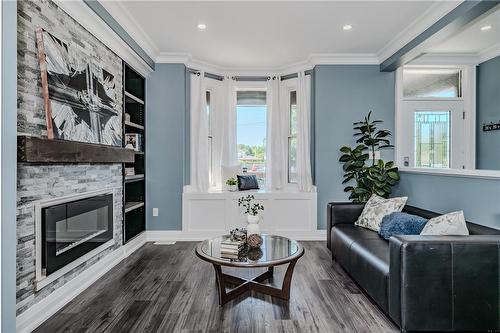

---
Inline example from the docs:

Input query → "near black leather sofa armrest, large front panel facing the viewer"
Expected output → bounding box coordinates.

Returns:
[389,235,500,331]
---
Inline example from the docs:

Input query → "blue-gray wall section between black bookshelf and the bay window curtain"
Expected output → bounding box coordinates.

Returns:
[146,64,189,230]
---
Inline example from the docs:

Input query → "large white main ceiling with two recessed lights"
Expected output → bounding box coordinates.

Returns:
[101,1,458,68]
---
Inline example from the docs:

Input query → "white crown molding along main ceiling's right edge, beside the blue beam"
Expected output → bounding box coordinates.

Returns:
[377,1,462,63]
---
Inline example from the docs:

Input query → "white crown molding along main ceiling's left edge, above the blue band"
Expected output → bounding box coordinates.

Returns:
[100,1,160,59]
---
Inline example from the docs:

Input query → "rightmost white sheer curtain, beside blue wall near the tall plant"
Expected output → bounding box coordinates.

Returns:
[297,72,313,192]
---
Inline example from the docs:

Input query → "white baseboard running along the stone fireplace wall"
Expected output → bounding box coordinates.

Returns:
[16,233,146,333]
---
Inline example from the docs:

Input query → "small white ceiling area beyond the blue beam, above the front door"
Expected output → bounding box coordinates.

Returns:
[427,9,500,54]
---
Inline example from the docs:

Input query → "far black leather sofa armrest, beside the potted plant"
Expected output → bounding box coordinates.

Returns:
[326,202,365,250]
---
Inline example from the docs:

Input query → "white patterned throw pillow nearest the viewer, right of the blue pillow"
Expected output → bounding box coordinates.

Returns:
[420,211,469,236]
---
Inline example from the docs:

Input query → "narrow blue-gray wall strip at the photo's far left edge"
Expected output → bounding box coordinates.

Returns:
[0,1,17,333]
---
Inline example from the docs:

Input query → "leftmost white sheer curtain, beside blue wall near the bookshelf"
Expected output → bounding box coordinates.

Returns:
[190,72,209,192]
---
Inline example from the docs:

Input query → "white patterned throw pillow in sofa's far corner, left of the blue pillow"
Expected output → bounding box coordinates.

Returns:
[354,194,408,232]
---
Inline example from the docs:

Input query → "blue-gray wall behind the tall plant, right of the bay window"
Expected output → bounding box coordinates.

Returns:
[313,65,395,229]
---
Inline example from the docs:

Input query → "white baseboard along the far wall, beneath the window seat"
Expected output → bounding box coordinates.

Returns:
[146,230,326,242]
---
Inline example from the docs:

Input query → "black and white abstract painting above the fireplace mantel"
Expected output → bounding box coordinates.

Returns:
[36,29,122,146]
